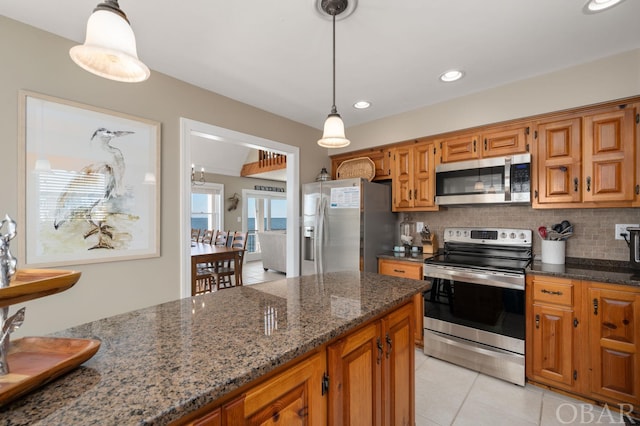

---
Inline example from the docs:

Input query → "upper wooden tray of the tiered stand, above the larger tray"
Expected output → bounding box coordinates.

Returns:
[0,269,80,307]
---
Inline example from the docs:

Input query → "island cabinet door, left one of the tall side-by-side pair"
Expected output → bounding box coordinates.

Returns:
[327,321,384,426]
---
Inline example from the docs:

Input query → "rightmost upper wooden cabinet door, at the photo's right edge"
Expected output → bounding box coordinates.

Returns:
[582,108,635,201]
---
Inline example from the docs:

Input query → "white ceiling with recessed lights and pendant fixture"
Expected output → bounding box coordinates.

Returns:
[0,0,640,133]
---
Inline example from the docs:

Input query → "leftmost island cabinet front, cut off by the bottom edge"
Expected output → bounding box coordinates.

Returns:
[244,351,327,426]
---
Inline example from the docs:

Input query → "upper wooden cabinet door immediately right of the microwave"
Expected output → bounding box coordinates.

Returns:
[536,117,582,203]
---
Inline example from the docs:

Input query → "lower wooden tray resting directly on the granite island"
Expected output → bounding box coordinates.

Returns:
[0,337,100,406]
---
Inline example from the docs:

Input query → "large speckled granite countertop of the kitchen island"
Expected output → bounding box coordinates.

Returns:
[0,272,430,426]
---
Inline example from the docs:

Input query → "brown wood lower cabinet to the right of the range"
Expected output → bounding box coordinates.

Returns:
[525,275,640,412]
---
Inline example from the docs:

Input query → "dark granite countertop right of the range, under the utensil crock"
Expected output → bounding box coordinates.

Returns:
[527,257,640,287]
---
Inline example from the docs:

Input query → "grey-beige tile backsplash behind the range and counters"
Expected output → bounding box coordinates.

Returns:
[404,206,640,261]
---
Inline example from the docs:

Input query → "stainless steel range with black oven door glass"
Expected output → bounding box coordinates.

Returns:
[424,228,532,386]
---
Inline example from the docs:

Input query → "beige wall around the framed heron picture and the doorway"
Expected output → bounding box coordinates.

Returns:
[0,16,329,335]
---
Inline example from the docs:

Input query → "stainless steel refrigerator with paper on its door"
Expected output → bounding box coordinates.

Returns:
[301,178,396,275]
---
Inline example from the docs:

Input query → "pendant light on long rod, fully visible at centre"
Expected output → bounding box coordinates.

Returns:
[318,0,351,148]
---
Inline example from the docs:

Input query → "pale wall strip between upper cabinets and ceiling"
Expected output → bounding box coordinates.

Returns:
[332,49,640,154]
